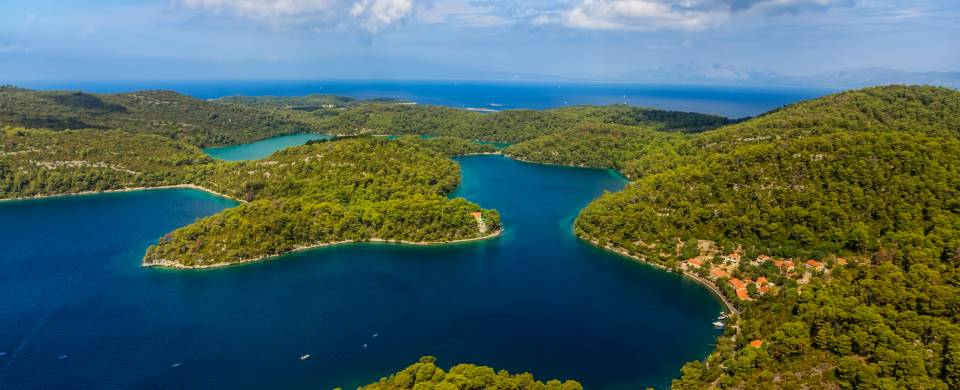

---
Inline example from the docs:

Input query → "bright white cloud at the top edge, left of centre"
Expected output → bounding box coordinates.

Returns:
[173,0,414,33]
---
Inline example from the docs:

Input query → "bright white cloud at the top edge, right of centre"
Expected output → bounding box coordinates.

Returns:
[556,0,853,30]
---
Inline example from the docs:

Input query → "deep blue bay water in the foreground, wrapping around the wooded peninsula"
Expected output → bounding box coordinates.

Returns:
[0,156,721,389]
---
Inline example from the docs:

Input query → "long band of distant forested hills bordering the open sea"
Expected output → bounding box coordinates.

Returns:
[0,86,733,148]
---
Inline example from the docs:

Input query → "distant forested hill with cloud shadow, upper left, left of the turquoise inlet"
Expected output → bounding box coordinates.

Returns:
[0,87,320,147]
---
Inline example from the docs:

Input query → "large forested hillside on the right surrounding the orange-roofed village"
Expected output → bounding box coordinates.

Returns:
[576,86,960,389]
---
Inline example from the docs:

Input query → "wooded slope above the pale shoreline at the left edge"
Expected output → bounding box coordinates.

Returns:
[0,128,213,199]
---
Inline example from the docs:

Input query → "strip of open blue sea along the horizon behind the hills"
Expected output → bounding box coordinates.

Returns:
[22,80,834,118]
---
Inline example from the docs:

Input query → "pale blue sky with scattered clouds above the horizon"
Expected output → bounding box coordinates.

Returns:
[0,0,960,83]
